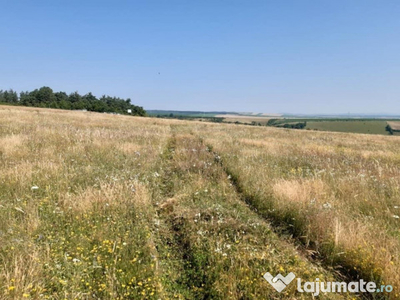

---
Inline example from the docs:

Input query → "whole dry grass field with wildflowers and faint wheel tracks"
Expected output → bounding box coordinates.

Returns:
[0,106,400,299]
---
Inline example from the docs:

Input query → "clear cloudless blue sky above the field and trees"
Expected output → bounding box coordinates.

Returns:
[0,0,400,114]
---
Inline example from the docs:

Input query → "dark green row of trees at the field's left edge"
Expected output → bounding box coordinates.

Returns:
[0,87,146,116]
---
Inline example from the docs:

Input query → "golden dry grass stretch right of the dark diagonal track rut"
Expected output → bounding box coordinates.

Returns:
[199,123,400,297]
